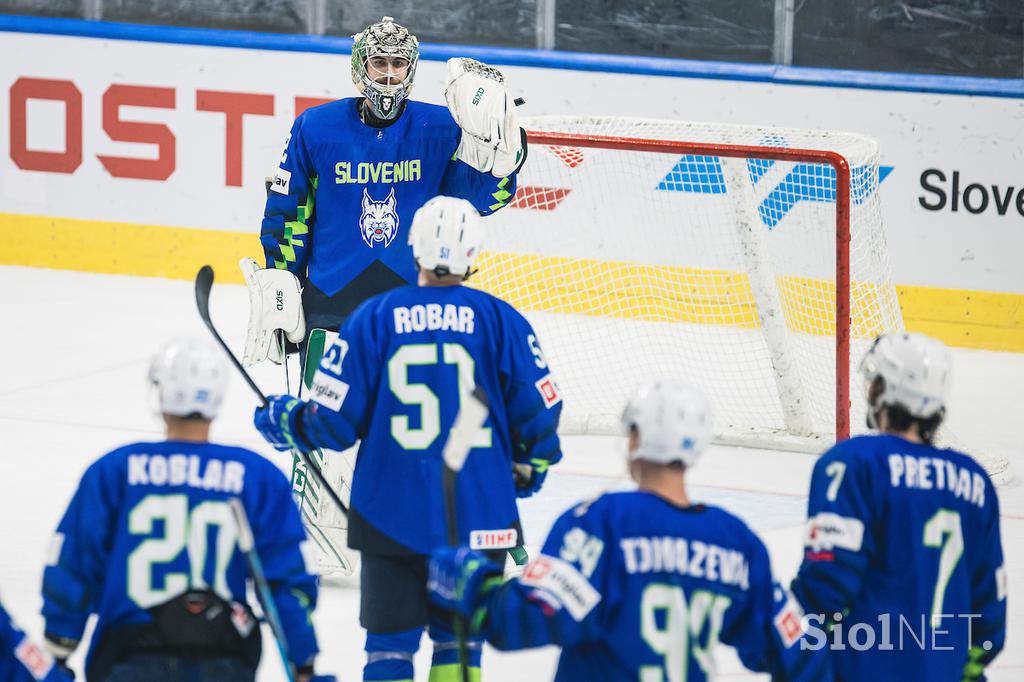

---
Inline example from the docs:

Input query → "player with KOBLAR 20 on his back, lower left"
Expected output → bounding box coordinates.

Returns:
[43,341,317,681]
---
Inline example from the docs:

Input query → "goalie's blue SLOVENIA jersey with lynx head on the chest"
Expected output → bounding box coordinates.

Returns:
[260,97,516,296]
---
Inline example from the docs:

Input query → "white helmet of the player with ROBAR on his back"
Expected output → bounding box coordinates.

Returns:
[409,197,483,279]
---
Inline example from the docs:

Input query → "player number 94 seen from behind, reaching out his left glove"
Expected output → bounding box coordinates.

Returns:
[429,381,830,682]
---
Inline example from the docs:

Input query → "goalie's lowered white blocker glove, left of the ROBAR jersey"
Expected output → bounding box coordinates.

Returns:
[239,258,306,367]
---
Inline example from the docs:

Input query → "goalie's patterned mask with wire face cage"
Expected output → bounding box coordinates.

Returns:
[352,16,420,121]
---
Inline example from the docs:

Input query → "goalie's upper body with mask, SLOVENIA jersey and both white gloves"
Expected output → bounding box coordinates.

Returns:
[243,16,526,366]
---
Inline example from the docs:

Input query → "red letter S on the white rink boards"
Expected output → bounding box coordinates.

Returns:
[96,85,175,180]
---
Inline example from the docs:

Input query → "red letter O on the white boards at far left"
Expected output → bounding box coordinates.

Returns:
[10,78,82,173]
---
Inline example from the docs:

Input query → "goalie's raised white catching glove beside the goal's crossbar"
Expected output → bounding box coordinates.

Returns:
[444,57,526,177]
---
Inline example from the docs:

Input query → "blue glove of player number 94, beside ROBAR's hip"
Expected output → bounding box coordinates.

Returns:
[427,547,503,632]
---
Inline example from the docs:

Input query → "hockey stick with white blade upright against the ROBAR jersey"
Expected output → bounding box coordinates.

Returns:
[442,386,489,682]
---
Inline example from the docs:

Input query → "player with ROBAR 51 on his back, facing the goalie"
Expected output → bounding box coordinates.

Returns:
[255,197,561,680]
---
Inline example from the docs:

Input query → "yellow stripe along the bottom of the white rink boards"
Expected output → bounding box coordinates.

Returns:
[0,213,1024,352]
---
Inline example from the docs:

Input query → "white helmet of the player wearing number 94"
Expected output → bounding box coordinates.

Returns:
[623,379,712,467]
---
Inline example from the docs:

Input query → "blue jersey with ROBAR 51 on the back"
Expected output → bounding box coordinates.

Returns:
[300,286,561,554]
